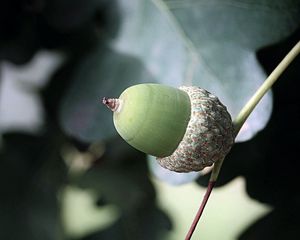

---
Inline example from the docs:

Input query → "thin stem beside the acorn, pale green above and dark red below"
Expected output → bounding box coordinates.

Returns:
[185,41,300,240]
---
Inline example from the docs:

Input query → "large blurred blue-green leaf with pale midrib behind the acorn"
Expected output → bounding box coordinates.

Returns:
[61,0,300,141]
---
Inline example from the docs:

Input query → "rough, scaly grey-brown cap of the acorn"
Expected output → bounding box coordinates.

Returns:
[157,86,234,172]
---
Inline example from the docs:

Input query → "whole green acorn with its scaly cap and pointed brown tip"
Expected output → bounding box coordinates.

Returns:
[102,83,234,172]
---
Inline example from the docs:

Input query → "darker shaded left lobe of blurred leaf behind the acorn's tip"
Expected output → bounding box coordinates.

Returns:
[60,43,154,142]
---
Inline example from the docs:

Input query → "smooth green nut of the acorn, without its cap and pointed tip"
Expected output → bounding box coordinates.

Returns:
[105,84,191,157]
